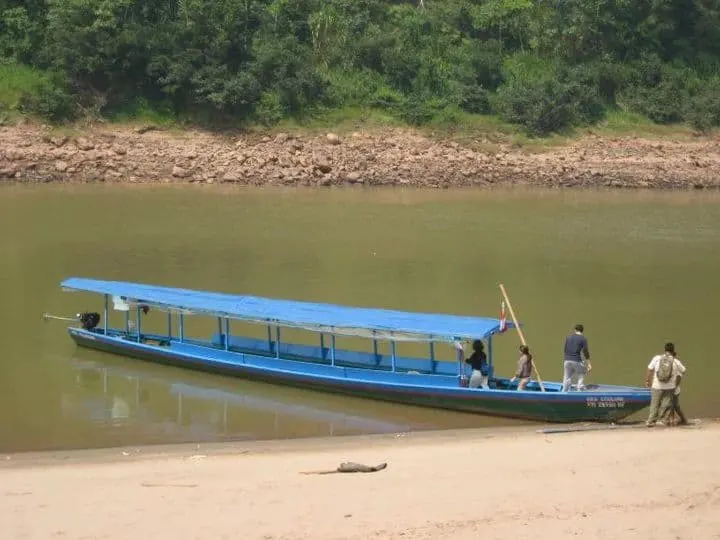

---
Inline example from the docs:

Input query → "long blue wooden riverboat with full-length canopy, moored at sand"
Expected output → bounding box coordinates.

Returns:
[61,278,650,422]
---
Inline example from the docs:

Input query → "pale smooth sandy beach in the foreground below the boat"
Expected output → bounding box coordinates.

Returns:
[0,422,720,540]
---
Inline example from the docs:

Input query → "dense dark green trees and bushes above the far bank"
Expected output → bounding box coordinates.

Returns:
[0,0,720,133]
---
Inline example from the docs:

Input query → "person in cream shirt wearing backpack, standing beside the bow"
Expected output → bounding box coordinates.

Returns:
[645,343,685,427]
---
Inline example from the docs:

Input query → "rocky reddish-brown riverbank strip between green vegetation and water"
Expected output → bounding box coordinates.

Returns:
[0,124,720,189]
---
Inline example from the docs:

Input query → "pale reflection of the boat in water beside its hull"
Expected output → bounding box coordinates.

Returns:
[68,358,417,442]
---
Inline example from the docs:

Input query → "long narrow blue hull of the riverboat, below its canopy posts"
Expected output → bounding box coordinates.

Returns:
[69,328,650,423]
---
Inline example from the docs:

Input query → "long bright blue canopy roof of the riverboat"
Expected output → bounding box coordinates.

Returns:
[61,277,514,342]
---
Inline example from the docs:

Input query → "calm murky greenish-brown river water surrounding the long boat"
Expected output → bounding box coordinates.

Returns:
[0,185,720,452]
